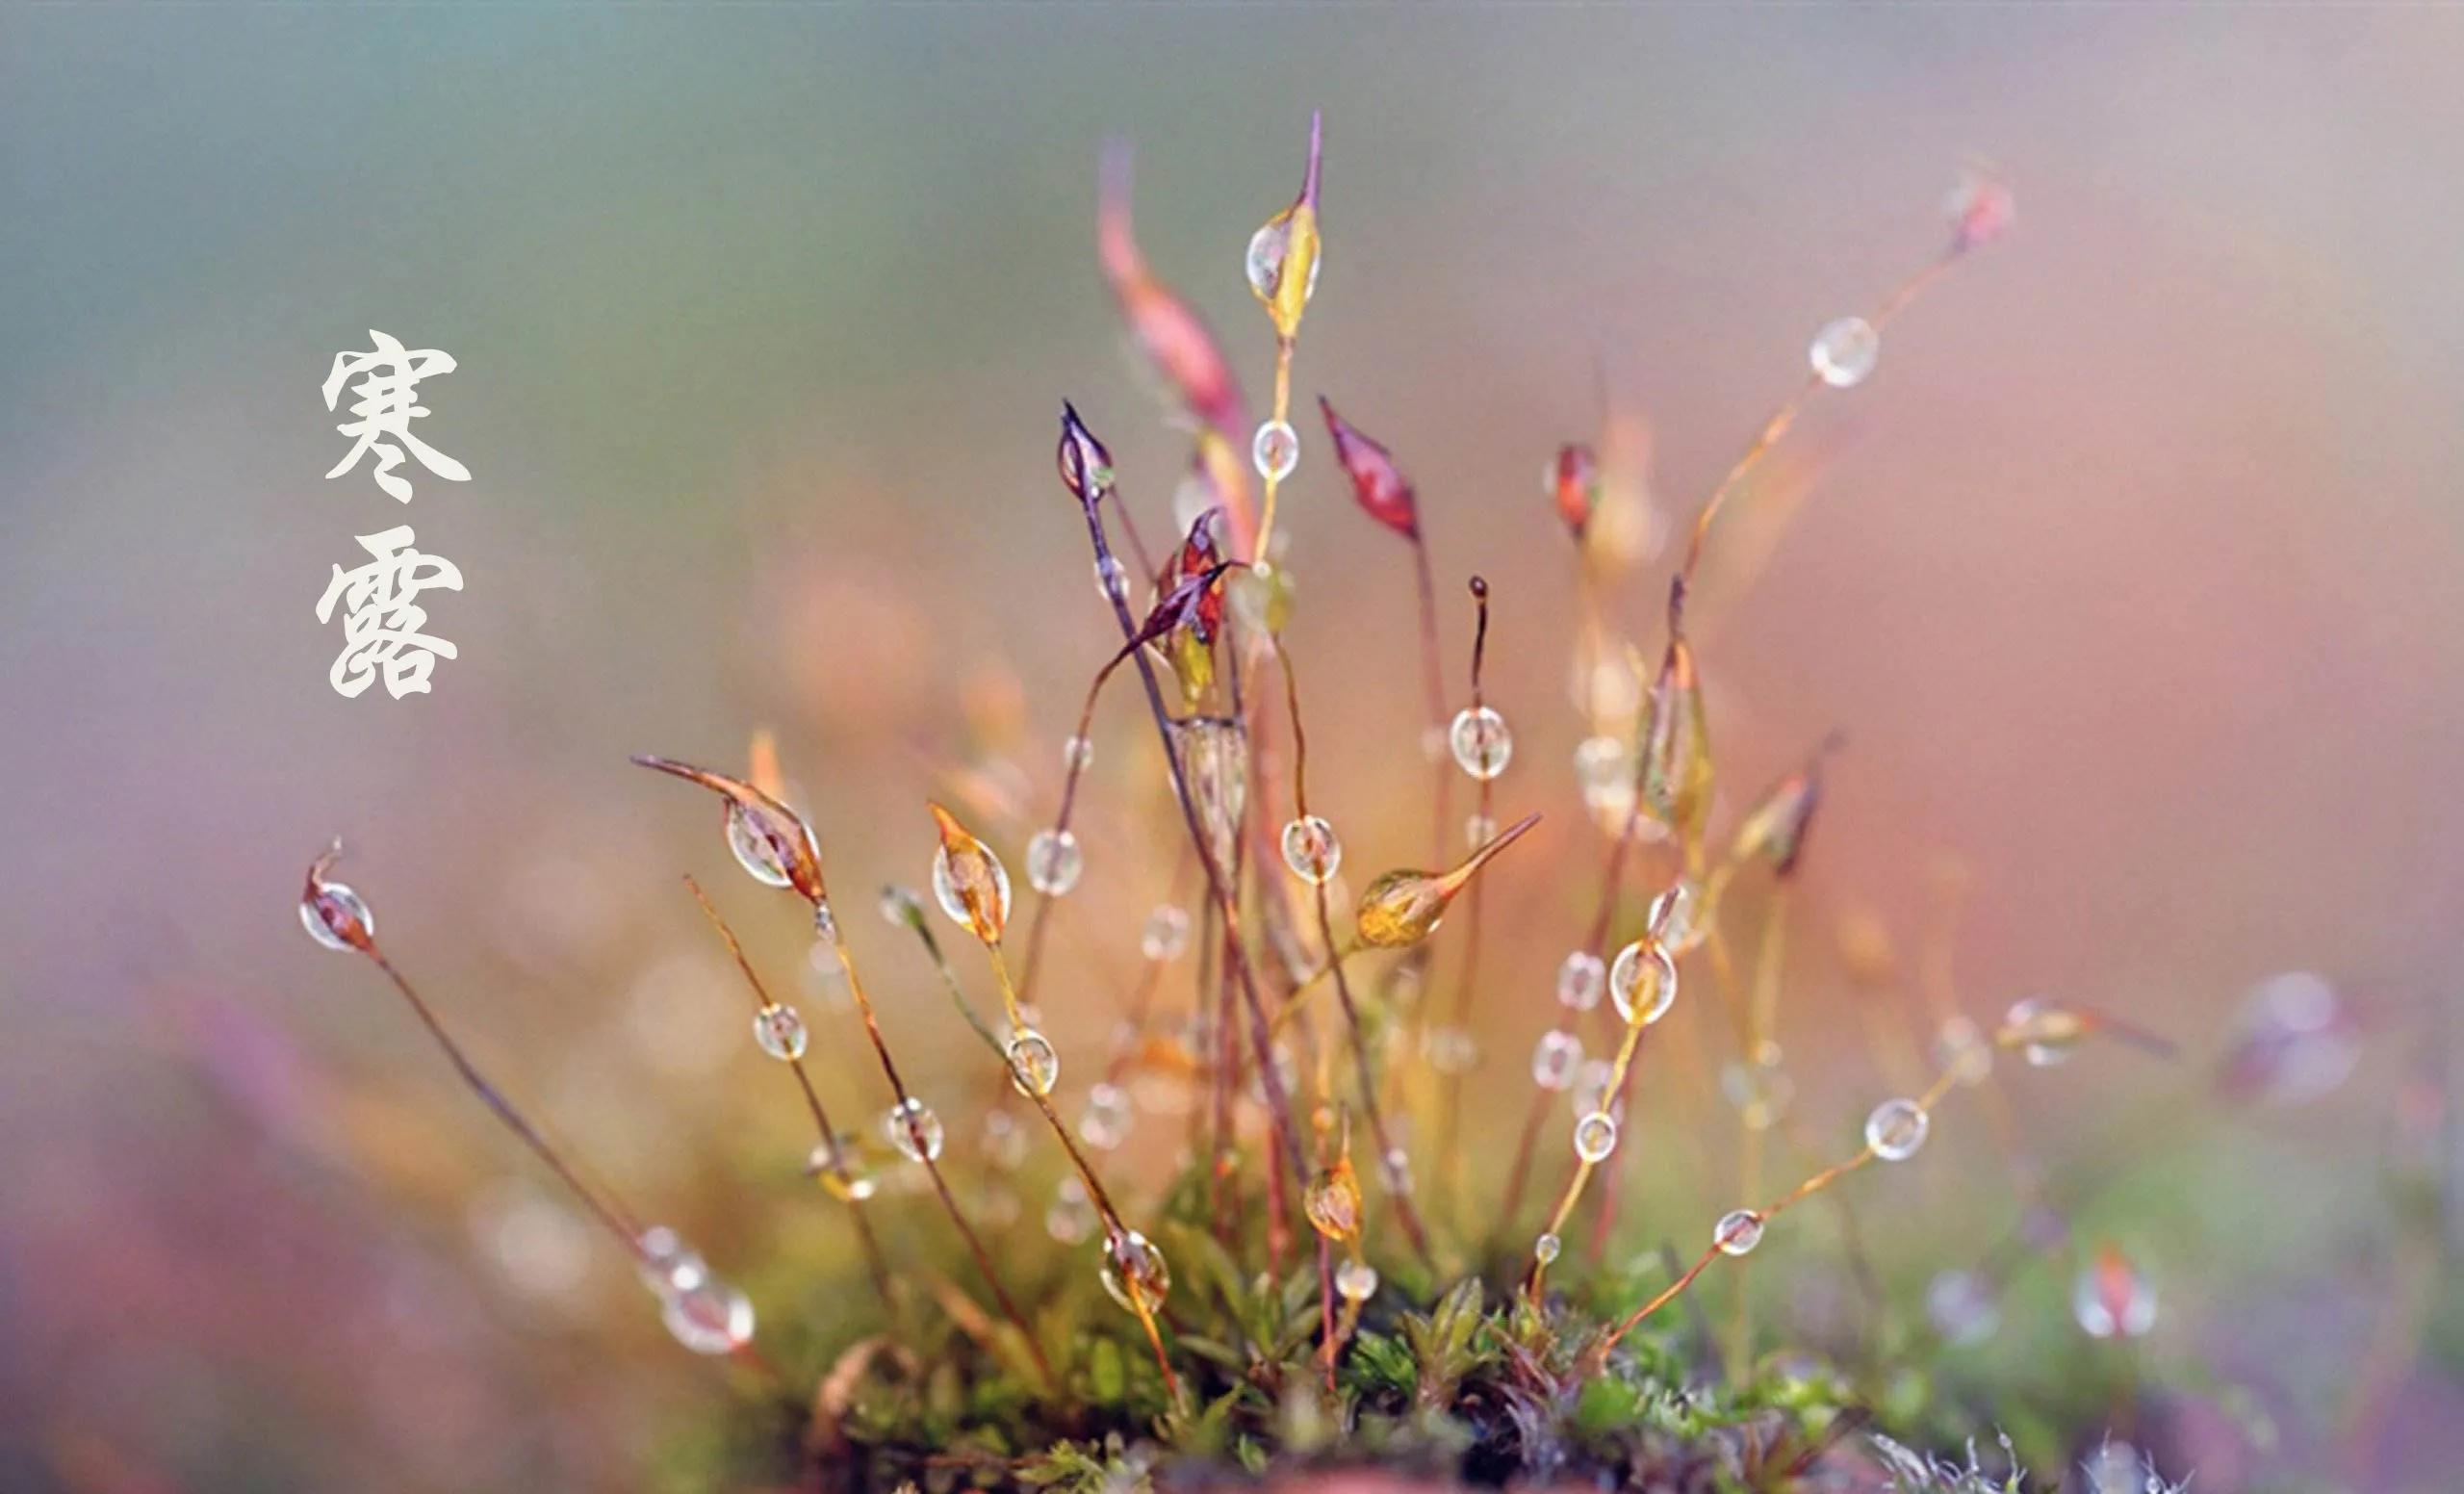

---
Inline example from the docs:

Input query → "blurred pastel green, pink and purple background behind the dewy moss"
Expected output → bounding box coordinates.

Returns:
[0,5,2464,1491]
